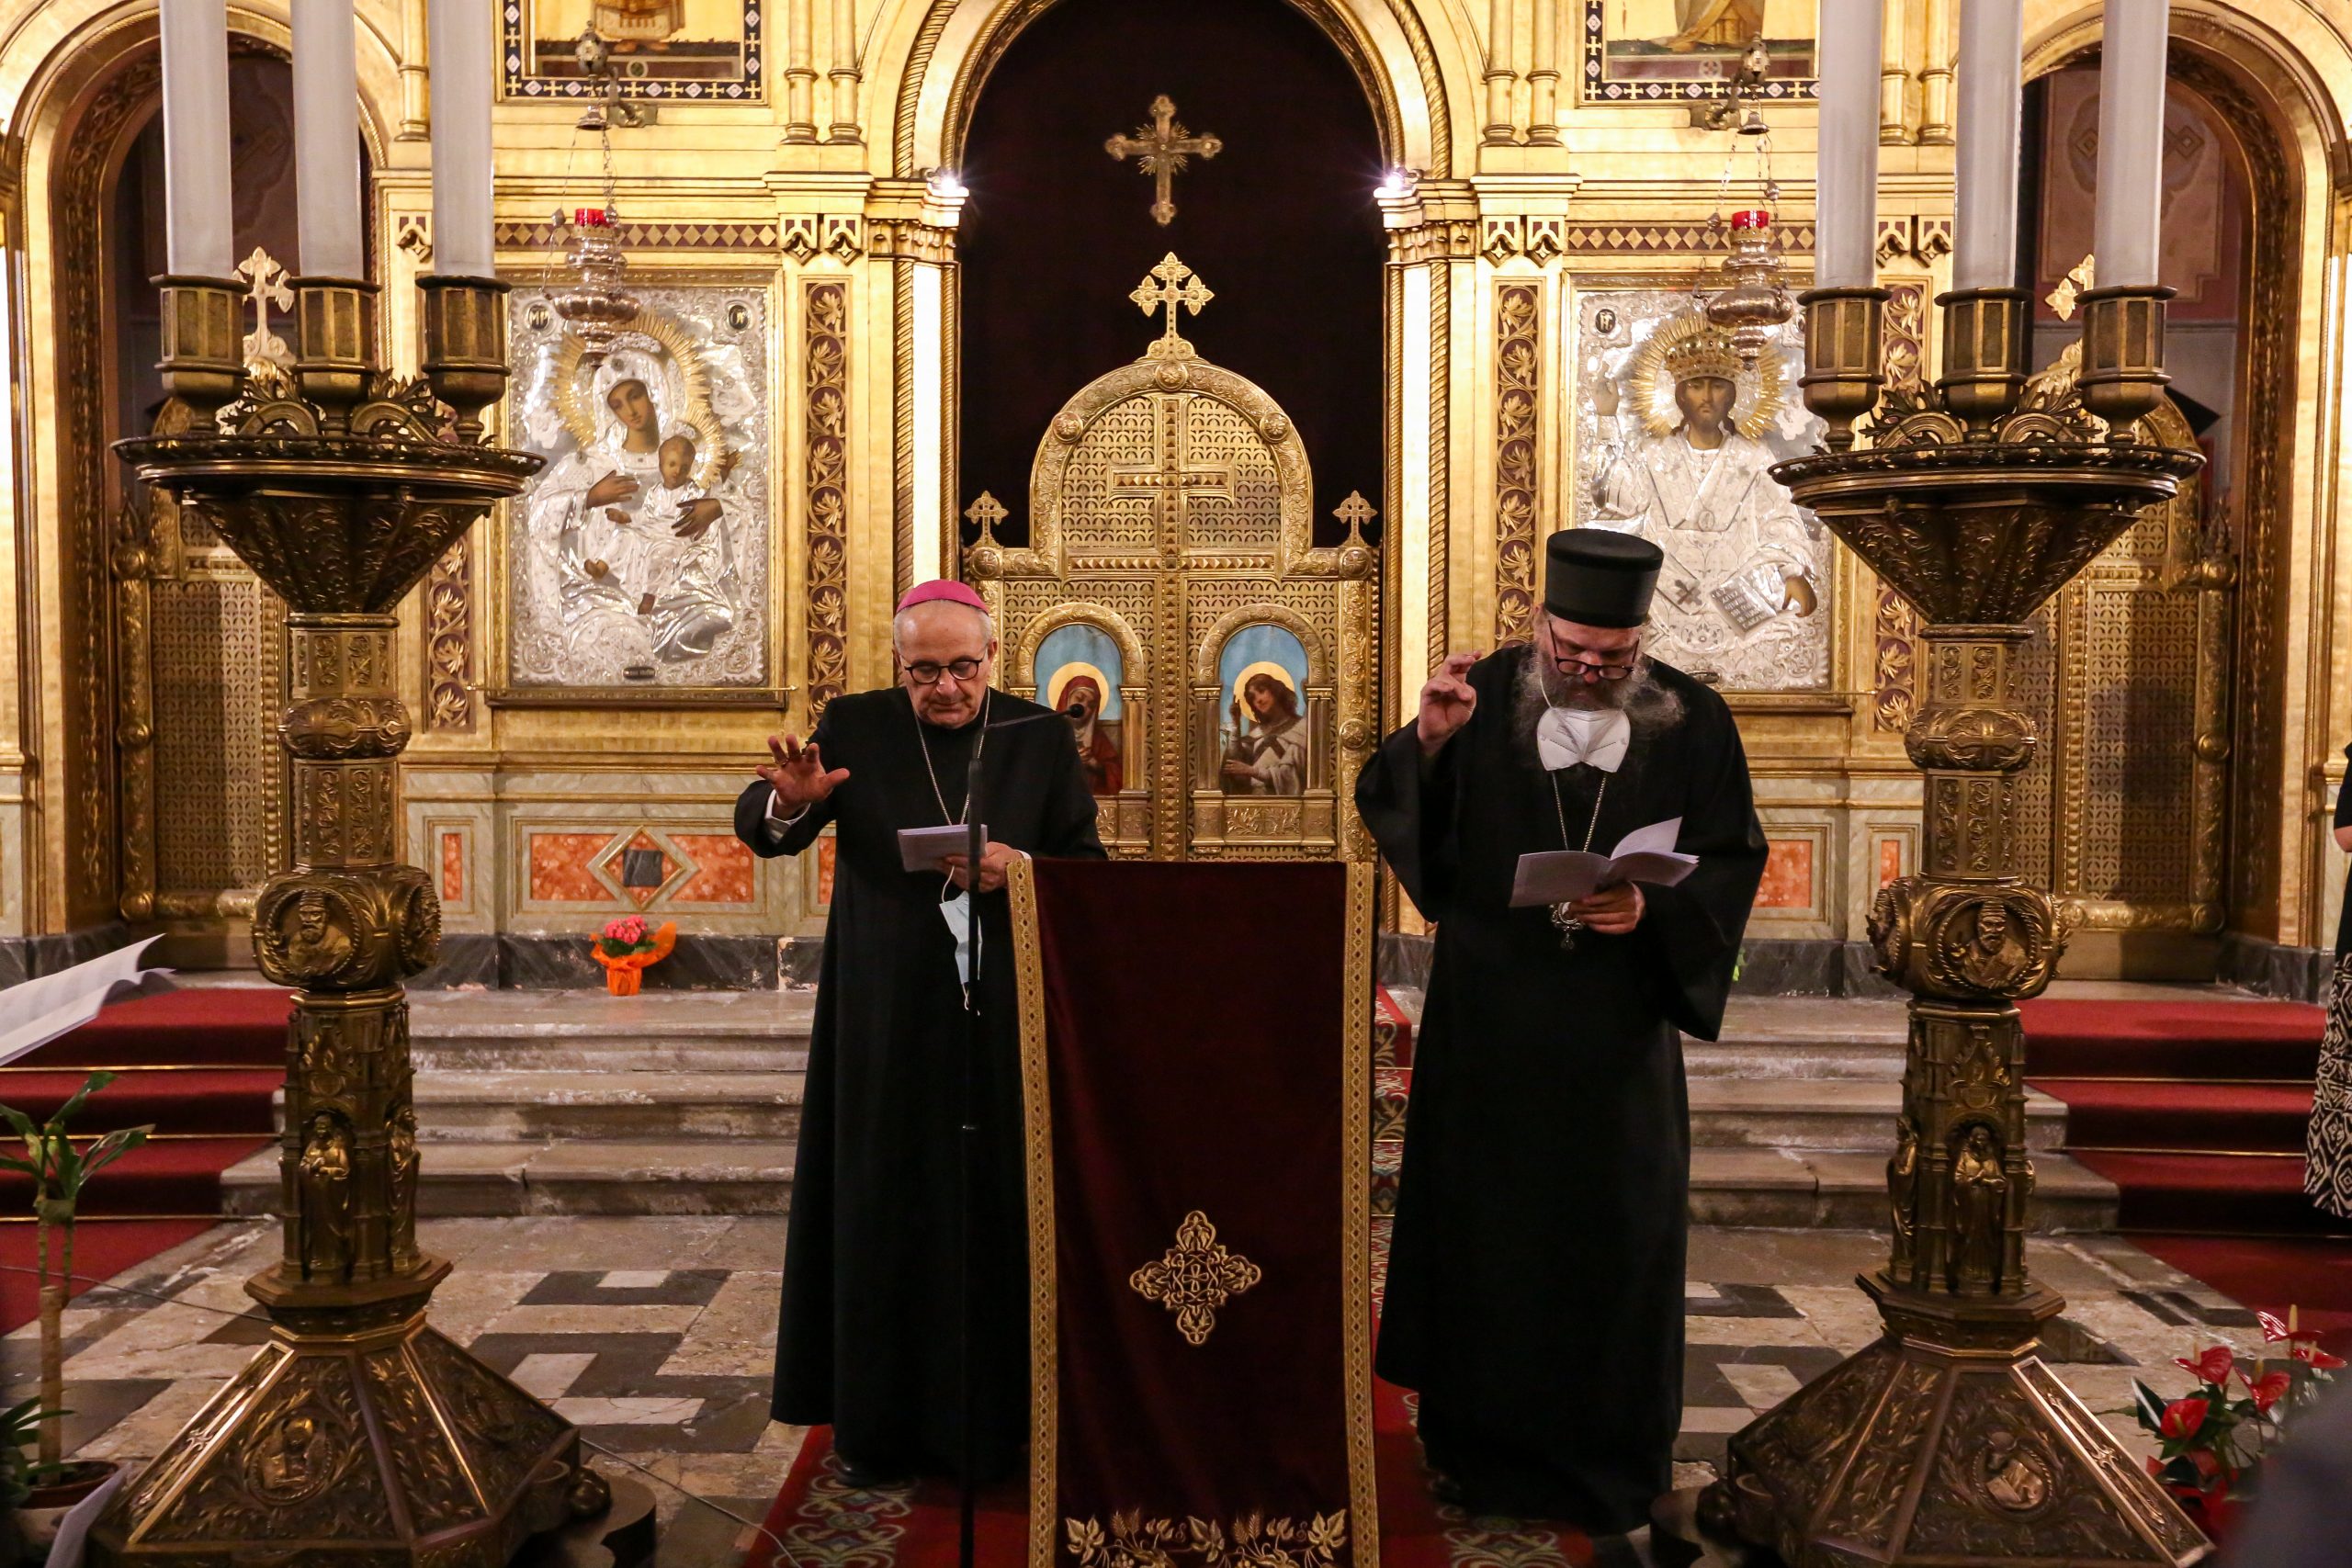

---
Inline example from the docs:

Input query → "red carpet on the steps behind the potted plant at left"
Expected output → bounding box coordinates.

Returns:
[0,985,287,1333]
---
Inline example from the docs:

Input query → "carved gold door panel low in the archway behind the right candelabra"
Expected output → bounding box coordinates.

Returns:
[2018,404,2234,976]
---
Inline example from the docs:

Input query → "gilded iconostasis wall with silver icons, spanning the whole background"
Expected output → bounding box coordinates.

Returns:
[0,0,2352,989]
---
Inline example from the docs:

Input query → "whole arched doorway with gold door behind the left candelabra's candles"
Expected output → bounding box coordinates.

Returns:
[28,18,374,966]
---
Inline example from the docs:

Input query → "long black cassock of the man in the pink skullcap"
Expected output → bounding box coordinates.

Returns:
[736,689,1103,1476]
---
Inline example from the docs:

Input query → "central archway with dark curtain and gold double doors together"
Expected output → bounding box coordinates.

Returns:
[953,0,1393,856]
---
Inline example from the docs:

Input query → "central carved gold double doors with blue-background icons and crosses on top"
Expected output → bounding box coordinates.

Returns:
[967,256,1376,858]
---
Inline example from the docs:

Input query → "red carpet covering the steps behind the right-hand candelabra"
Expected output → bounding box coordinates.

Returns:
[2018,999,2352,1241]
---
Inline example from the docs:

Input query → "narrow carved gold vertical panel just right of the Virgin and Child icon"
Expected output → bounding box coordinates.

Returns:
[799,277,849,724]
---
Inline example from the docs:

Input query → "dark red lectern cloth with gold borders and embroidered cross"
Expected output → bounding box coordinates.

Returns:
[1012,861,1381,1568]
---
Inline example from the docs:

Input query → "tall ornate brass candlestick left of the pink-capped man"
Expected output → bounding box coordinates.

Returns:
[89,277,606,1568]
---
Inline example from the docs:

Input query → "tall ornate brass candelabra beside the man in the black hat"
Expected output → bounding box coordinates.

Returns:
[1701,289,2206,1568]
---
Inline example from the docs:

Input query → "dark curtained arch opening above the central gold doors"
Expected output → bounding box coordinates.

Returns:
[957,0,1387,543]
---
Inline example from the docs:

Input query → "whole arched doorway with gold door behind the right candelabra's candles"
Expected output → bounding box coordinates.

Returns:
[2018,40,2290,980]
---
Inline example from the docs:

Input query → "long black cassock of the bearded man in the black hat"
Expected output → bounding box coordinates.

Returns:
[1355,647,1764,1533]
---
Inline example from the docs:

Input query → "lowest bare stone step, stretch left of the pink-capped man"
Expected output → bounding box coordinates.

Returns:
[221,1138,795,1215]
